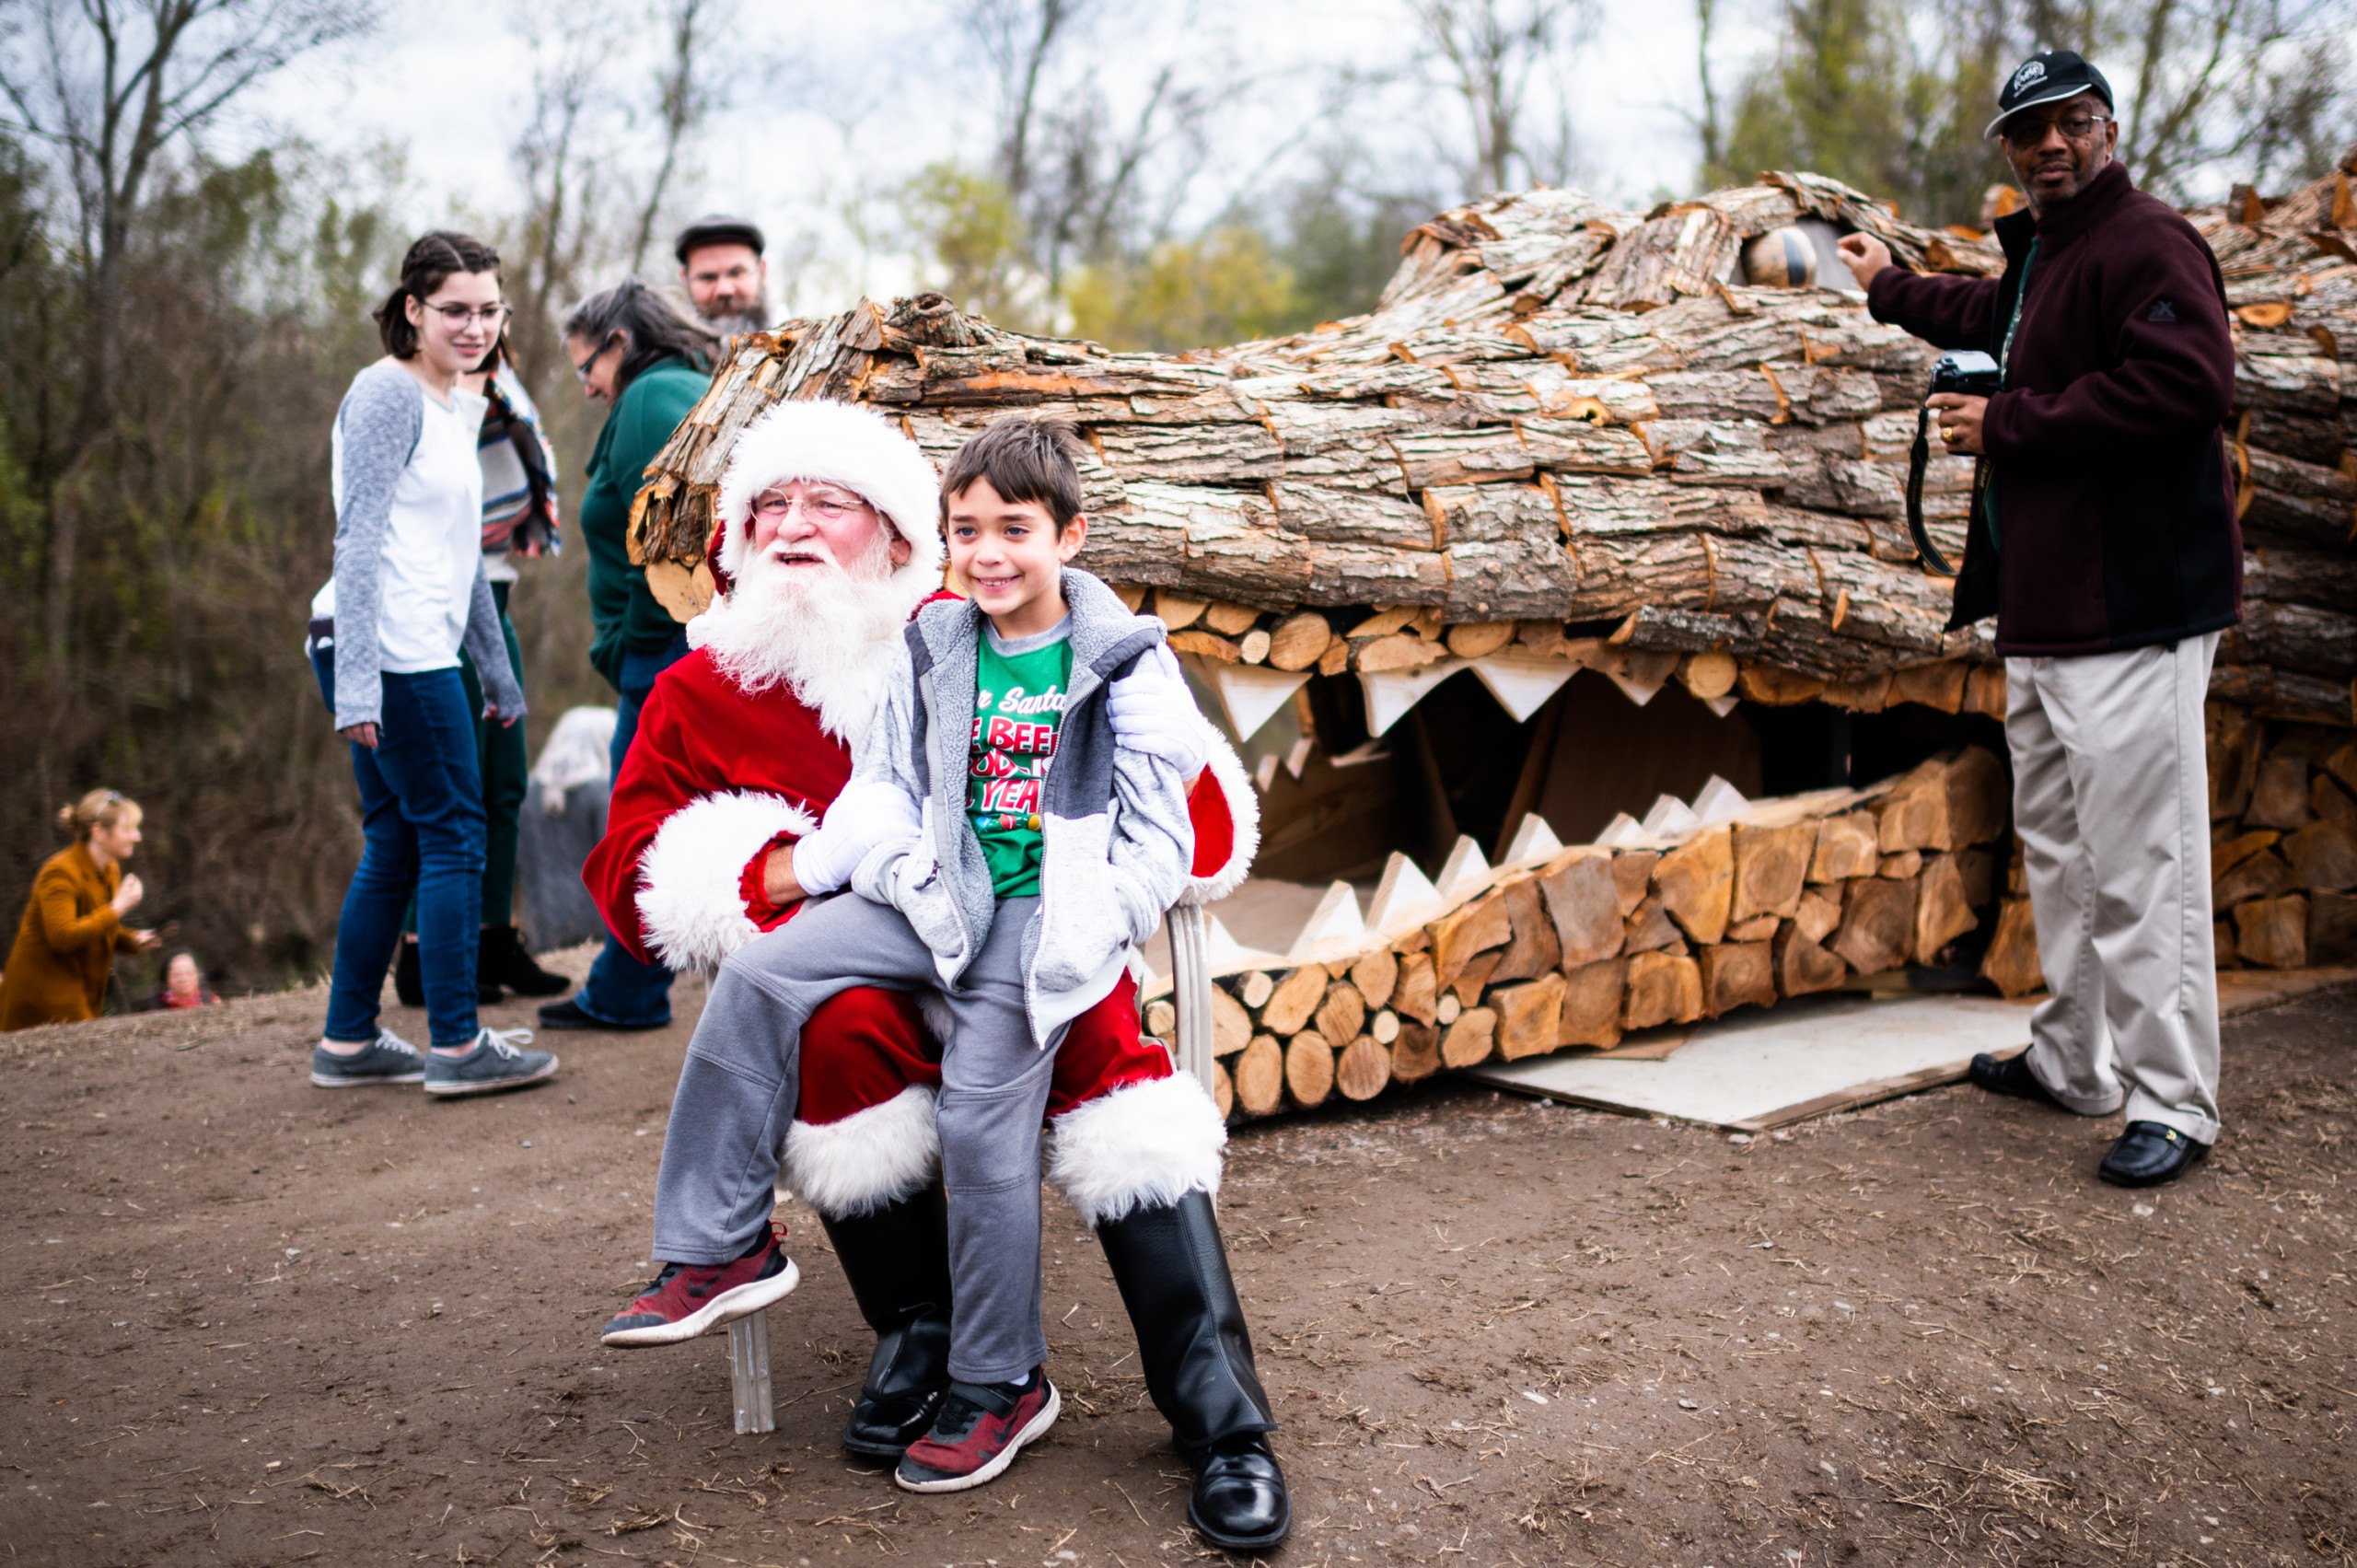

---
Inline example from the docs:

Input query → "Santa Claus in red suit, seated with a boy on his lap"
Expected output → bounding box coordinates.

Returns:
[585,401,1289,1550]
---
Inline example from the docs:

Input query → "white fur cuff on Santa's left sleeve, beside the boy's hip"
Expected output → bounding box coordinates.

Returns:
[639,790,818,974]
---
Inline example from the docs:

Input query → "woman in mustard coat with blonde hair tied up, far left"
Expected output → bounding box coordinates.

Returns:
[0,790,158,1033]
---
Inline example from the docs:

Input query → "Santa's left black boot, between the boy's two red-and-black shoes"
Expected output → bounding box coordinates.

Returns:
[820,1186,950,1459]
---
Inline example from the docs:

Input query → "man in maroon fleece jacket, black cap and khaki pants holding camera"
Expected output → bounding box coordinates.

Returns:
[1840,50,2242,1186]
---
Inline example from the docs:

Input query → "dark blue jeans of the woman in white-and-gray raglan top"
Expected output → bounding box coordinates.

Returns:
[311,648,483,1050]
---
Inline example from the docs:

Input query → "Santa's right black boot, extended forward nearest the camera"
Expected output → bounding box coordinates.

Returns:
[1096,1193,1294,1551]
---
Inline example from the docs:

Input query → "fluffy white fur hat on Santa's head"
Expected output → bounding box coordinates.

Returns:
[704,401,940,604]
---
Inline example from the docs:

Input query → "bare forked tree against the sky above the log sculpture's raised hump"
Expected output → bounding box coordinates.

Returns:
[1411,0,1596,191]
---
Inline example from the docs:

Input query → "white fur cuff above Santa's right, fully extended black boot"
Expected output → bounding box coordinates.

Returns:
[1047,1073,1228,1226]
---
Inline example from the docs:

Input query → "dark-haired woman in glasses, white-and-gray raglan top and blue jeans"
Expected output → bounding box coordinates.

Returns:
[308,231,556,1097]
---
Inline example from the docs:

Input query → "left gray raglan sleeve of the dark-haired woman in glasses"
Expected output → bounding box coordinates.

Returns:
[335,368,422,728]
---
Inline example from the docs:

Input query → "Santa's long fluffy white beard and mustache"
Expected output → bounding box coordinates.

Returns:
[689,538,924,745]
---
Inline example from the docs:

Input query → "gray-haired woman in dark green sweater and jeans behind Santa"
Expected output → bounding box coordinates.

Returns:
[540,278,716,1030]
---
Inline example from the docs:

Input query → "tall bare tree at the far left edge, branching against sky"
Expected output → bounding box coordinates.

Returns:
[0,0,375,665]
